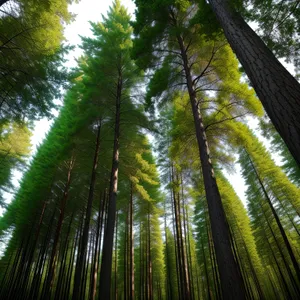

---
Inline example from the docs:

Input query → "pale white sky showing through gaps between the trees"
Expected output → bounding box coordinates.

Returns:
[0,0,286,214]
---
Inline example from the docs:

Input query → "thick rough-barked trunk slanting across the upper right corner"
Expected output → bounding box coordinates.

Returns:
[209,0,300,165]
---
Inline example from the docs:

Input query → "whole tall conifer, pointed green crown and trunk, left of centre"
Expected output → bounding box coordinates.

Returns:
[77,1,139,299]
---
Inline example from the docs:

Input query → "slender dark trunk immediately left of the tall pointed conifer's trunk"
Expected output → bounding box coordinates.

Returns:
[72,121,101,300]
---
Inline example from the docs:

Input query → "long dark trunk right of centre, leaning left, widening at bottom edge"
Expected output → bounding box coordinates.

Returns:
[177,31,246,300]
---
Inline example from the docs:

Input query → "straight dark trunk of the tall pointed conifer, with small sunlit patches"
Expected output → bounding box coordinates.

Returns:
[99,71,123,300]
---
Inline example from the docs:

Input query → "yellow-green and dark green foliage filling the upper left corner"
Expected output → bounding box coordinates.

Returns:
[0,1,75,122]
